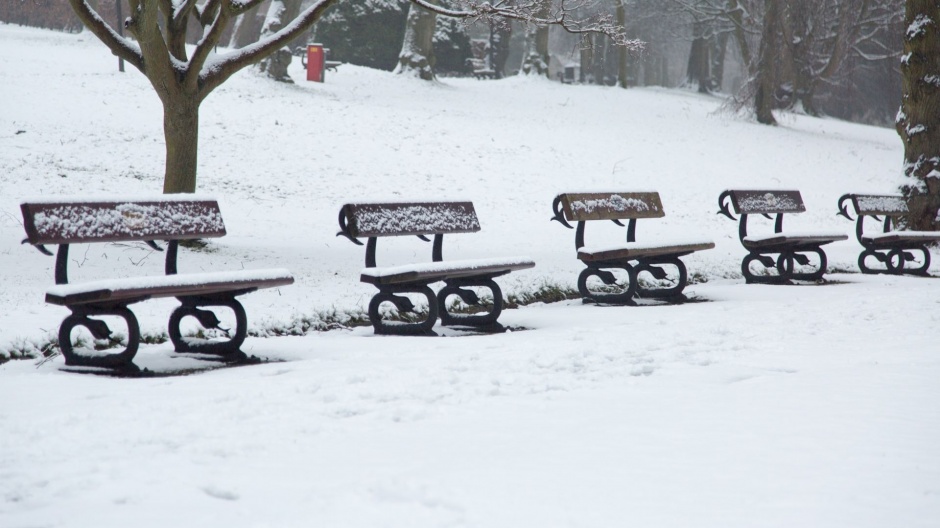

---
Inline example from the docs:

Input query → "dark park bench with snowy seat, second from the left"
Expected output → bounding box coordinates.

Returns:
[337,202,535,335]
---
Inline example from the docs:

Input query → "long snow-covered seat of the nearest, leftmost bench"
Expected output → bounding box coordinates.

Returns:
[46,268,294,306]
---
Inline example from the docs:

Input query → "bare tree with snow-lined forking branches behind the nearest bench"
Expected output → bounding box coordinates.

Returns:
[69,0,631,193]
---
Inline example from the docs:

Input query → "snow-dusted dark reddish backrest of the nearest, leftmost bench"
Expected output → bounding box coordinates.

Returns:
[20,195,225,244]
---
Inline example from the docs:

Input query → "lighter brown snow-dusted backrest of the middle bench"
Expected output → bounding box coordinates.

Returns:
[558,192,666,222]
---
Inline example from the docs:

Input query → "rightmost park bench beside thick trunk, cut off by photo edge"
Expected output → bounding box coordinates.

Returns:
[838,194,940,275]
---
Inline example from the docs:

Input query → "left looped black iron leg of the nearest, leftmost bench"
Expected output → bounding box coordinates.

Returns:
[59,305,140,370]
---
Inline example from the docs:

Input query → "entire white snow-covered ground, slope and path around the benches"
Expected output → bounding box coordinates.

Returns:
[0,25,940,528]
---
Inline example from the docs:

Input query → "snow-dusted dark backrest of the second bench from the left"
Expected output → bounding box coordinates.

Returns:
[340,202,480,237]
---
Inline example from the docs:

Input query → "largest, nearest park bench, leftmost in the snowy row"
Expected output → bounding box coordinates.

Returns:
[20,195,294,371]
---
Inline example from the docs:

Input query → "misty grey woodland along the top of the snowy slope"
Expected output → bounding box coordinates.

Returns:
[0,0,905,126]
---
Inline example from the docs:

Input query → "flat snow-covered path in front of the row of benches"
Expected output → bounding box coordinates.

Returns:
[0,275,940,528]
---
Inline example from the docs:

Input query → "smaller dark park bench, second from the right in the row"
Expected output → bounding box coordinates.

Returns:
[718,190,849,284]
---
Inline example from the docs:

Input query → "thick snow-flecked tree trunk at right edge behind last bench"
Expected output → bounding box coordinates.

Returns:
[897,0,940,230]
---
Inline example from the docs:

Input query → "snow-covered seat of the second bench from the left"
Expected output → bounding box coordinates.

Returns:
[360,257,535,285]
